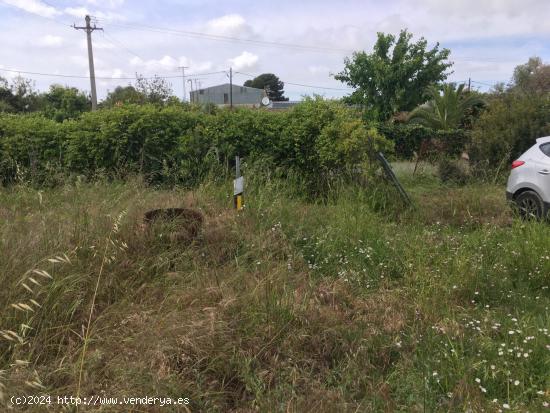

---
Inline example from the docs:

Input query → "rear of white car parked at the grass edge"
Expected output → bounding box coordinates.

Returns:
[506,136,550,219]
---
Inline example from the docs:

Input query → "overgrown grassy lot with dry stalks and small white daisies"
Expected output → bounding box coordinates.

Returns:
[0,168,550,412]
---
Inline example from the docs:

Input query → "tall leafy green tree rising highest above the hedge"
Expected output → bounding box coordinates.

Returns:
[334,30,452,120]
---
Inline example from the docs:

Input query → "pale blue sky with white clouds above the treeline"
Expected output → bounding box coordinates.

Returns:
[0,0,550,100]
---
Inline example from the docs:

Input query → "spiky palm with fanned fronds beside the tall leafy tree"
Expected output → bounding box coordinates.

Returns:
[408,83,483,130]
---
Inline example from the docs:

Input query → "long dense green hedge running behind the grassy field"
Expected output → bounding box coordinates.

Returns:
[0,98,393,192]
